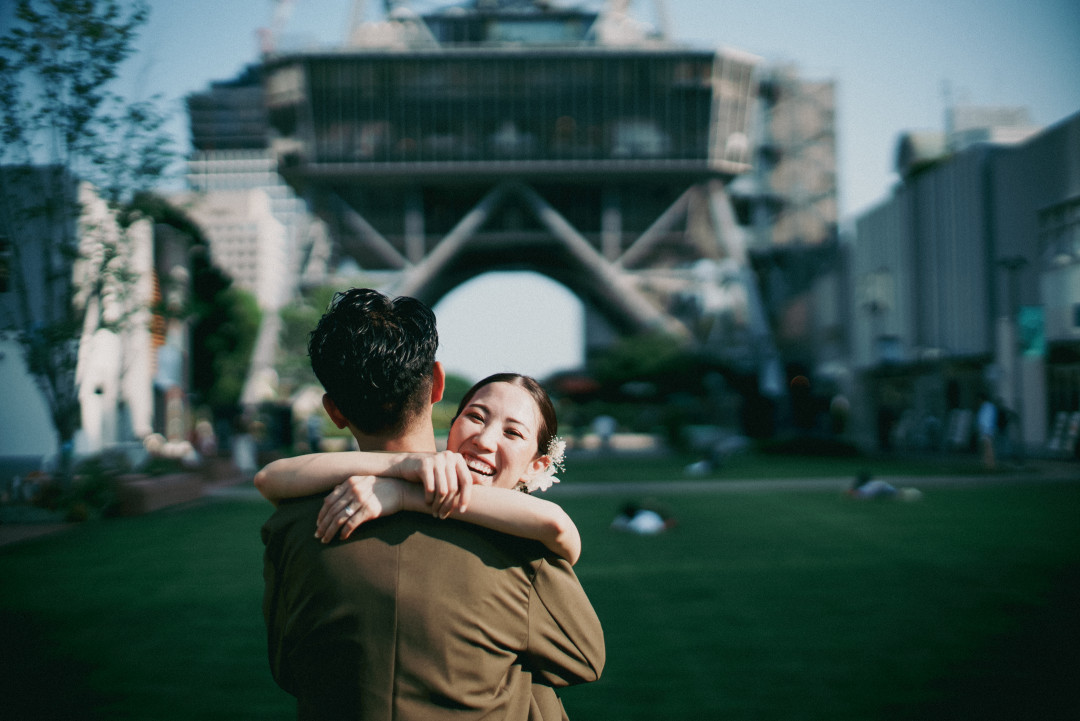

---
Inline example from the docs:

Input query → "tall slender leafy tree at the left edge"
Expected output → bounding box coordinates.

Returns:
[0,0,170,476]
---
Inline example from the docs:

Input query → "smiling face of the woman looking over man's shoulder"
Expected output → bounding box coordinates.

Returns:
[446,383,543,488]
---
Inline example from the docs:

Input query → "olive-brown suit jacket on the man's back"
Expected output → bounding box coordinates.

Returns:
[262,498,605,721]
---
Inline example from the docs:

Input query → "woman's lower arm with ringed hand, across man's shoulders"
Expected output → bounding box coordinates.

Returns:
[315,476,581,563]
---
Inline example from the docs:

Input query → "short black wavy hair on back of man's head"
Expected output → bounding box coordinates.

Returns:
[308,288,438,436]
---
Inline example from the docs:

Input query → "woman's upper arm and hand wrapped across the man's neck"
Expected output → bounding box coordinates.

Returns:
[255,451,472,517]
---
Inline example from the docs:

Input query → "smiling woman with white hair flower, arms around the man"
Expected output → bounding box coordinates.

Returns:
[255,373,581,563]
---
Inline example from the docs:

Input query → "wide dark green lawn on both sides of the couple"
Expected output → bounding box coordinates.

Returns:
[0,462,1080,721]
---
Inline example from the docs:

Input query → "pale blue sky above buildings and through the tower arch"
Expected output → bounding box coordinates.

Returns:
[123,0,1080,378]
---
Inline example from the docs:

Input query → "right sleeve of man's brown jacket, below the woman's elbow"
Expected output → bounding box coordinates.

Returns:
[525,557,606,688]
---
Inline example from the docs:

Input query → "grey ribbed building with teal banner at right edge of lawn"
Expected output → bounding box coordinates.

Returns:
[852,106,1080,449]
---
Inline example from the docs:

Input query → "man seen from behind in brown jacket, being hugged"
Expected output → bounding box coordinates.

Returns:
[262,289,605,721]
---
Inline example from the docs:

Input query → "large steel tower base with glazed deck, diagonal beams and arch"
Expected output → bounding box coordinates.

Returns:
[264,0,767,354]
